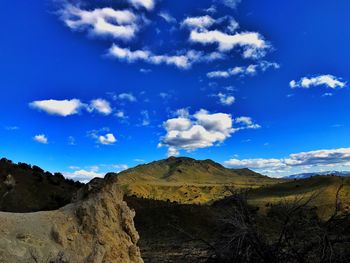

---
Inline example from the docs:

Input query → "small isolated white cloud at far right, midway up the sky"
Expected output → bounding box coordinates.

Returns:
[289,74,347,89]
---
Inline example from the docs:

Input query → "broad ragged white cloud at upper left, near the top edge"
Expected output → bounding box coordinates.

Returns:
[61,5,139,40]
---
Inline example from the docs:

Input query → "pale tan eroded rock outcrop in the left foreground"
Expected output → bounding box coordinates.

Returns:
[0,175,143,263]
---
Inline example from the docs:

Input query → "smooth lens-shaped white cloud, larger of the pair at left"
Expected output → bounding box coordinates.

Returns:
[29,99,84,117]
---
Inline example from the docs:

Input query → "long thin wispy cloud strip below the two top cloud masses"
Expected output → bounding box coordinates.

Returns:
[108,44,224,69]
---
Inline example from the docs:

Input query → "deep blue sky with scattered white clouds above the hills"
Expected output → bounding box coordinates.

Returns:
[0,0,350,180]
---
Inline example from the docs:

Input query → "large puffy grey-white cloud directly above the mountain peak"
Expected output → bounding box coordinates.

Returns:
[159,109,234,155]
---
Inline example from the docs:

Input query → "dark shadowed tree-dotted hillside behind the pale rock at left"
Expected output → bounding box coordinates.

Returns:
[0,158,82,212]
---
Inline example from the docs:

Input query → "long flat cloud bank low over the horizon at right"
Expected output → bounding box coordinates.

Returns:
[225,148,350,173]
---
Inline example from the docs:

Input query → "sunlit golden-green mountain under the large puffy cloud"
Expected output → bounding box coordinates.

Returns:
[117,157,281,204]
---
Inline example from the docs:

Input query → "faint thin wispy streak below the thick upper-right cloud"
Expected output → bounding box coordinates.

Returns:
[207,61,280,78]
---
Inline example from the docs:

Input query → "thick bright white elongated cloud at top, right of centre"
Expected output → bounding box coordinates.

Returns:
[190,30,269,58]
